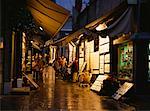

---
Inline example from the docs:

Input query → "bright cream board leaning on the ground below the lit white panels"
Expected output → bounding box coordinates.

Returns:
[90,75,108,92]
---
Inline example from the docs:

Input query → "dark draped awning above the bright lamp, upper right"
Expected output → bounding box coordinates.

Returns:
[85,2,135,37]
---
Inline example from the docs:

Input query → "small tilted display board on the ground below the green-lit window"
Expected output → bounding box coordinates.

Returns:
[112,82,133,100]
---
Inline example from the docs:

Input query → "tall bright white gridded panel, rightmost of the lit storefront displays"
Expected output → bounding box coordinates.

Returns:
[99,36,110,74]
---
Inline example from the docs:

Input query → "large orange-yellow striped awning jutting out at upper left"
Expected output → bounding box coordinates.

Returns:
[27,0,69,37]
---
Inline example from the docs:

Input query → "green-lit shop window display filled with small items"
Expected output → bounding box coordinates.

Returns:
[118,42,133,80]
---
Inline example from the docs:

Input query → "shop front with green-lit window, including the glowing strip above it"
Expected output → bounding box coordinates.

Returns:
[113,35,133,82]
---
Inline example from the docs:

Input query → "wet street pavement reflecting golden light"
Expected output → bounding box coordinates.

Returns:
[0,66,135,111]
